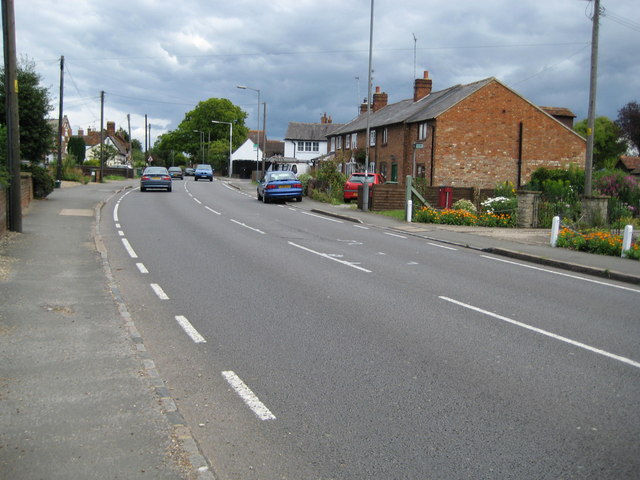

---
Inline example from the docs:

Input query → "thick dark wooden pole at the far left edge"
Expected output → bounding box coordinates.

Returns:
[2,0,22,232]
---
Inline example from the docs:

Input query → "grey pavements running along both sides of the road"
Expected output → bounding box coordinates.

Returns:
[0,178,640,480]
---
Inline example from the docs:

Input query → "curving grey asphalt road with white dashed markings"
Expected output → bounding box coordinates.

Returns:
[100,180,640,479]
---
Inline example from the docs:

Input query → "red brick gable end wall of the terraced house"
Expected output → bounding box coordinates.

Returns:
[432,82,586,188]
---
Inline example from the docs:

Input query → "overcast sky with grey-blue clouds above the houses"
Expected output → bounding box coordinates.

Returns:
[10,0,640,146]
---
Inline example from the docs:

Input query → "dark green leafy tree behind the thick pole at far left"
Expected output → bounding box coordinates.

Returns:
[0,59,55,162]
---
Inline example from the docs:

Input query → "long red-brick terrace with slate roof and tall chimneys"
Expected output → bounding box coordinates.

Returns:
[328,72,586,188]
